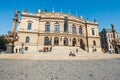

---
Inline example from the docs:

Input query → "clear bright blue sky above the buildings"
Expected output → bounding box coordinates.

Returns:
[0,0,120,35]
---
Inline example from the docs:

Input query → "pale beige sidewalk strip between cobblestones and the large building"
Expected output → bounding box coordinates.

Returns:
[0,52,120,60]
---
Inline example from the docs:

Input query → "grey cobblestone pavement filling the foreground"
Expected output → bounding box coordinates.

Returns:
[0,58,120,80]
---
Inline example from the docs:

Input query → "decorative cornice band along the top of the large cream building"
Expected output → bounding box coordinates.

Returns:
[22,12,98,26]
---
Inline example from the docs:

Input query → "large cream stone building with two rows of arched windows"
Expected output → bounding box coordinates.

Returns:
[15,10,101,52]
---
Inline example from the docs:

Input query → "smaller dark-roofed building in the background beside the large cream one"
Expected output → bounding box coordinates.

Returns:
[100,28,119,52]
